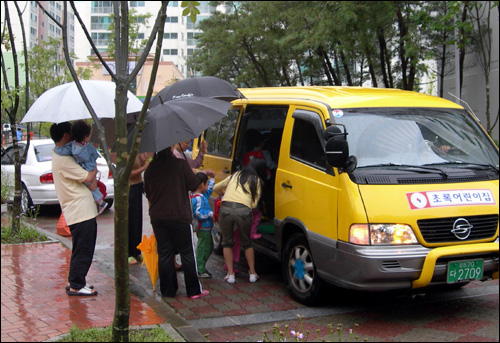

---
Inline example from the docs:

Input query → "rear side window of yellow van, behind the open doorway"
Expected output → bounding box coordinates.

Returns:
[205,109,239,157]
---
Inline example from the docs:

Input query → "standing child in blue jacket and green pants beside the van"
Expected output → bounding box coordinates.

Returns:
[191,172,215,278]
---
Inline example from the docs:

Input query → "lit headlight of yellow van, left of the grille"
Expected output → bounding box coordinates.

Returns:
[349,224,418,245]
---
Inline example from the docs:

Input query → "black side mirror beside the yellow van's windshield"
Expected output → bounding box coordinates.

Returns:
[323,124,357,173]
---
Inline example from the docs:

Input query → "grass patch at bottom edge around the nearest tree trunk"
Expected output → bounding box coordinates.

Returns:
[57,326,175,342]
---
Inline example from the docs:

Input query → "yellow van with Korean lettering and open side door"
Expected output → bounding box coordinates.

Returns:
[197,87,499,304]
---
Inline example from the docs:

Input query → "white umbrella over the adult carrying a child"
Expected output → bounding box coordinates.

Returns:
[21,80,143,123]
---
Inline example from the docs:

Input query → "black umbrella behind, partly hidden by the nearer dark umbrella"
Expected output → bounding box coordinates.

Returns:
[149,76,243,108]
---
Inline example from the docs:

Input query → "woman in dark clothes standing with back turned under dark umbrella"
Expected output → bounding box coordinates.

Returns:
[144,147,209,299]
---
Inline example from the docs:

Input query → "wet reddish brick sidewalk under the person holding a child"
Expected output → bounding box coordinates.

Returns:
[1,243,165,342]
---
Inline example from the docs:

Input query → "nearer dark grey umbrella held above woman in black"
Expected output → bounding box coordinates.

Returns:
[139,97,231,152]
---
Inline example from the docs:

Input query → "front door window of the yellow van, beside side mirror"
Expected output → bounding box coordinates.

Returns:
[290,118,326,168]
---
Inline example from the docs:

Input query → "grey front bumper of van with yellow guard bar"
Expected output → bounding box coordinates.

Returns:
[315,240,499,291]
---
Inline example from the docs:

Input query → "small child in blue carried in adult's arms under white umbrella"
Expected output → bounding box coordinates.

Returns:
[54,120,107,215]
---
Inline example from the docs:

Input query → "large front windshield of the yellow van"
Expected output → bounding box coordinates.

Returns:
[334,108,499,169]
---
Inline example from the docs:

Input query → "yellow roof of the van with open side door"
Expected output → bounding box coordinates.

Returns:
[234,86,463,109]
